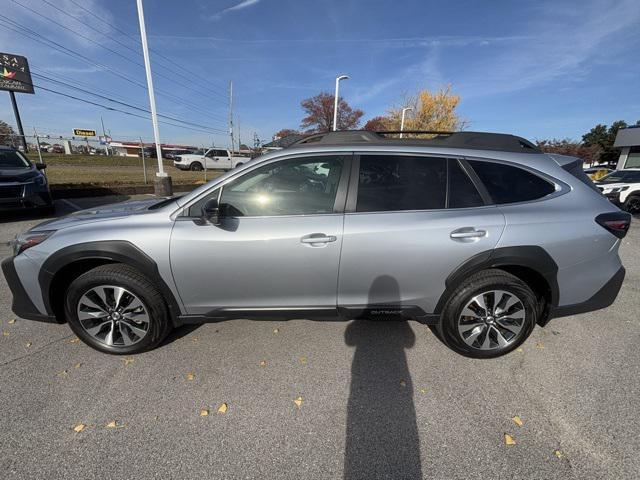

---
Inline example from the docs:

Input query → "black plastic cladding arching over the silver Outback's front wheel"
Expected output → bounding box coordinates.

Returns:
[38,240,181,326]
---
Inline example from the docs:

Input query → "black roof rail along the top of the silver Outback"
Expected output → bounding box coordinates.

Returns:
[291,130,542,153]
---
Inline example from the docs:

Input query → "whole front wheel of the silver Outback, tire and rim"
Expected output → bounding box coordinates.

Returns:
[65,264,171,354]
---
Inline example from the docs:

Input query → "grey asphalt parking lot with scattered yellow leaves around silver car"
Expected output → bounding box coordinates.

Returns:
[0,199,640,480]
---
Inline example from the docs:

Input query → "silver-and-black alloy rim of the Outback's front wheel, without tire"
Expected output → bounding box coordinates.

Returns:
[77,285,150,347]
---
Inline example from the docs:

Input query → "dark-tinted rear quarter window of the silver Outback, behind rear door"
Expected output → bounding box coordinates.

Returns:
[468,160,555,204]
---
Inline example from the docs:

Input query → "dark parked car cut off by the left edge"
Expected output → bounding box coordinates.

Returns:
[0,145,54,212]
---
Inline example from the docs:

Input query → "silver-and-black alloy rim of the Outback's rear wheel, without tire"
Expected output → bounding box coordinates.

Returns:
[458,290,526,350]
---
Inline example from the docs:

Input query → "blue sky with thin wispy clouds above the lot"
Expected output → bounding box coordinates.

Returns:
[0,0,640,145]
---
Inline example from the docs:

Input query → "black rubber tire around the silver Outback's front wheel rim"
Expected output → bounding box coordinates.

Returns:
[65,263,172,355]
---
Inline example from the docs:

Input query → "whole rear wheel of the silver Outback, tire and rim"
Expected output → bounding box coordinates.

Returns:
[439,270,538,358]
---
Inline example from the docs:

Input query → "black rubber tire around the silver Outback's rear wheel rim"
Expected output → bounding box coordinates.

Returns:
[437,269,539,358]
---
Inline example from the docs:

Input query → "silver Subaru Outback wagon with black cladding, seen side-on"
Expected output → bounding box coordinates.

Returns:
[2,131,631,358]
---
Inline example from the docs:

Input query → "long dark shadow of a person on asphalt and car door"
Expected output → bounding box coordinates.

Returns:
[344,276,422,480]
